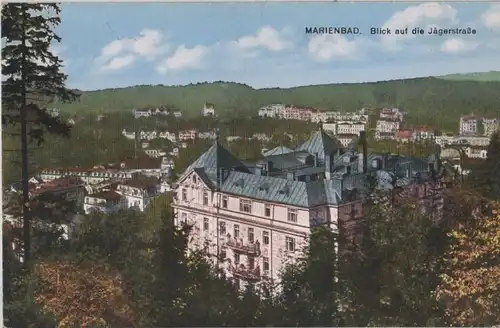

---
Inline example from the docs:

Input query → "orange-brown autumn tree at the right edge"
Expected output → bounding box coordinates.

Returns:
[438,202,500,326]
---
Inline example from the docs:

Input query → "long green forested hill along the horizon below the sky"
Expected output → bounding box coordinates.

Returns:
[56,77,500,128]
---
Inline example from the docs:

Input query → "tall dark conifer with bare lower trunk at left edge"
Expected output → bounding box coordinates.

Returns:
[2,3,77,263]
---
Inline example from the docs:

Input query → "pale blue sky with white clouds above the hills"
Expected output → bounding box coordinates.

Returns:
[48,2,500,90]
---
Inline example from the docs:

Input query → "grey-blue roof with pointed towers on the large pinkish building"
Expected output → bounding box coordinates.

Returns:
[181,131,440,208]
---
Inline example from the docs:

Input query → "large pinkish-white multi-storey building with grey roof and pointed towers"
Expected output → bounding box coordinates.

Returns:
[173,130,446,286]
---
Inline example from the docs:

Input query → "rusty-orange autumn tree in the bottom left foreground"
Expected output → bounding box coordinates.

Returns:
[35,260,134,328]
